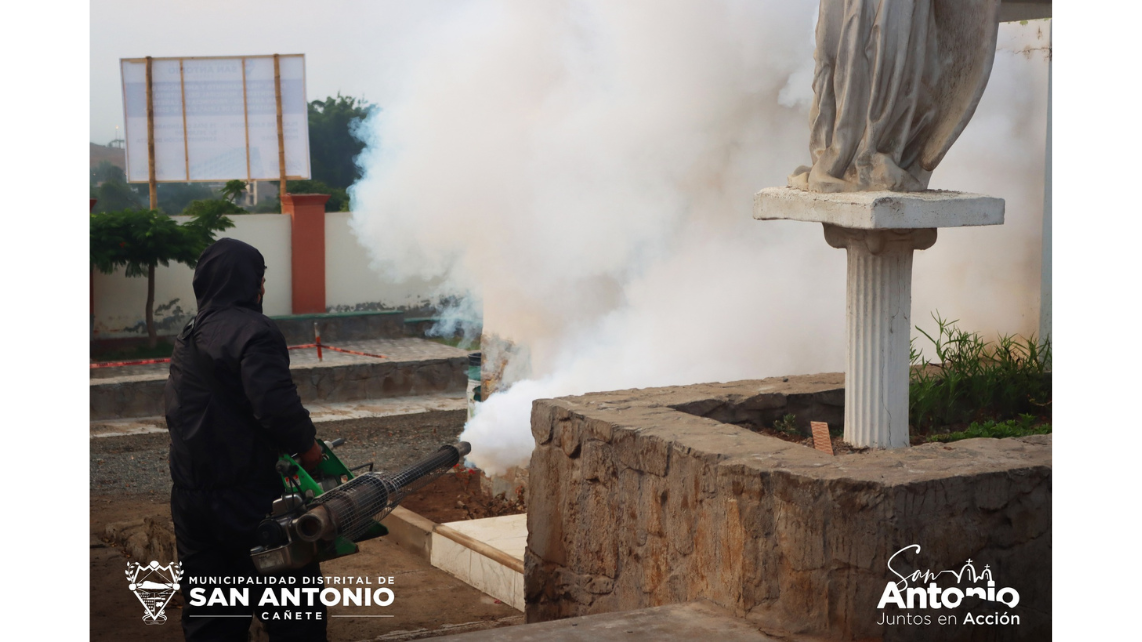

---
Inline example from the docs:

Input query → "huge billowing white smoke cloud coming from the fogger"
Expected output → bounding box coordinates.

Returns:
[353,0,1045,473]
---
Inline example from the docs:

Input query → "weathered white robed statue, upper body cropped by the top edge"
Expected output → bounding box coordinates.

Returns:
[789,0,999,192]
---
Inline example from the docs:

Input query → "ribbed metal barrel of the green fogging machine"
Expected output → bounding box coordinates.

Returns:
[295,441,472,541]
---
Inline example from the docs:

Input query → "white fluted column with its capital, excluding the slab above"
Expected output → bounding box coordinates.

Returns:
[825,224,936,448]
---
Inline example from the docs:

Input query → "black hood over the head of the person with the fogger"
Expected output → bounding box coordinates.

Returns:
[194,239,266,314]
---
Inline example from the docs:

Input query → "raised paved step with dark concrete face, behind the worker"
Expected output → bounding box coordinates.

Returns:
[90,338,468,420]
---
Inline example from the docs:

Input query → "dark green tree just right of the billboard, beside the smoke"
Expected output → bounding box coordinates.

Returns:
[308,93,377,189]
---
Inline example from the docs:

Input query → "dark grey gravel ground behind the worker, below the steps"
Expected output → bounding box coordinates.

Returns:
[90,410,466,496]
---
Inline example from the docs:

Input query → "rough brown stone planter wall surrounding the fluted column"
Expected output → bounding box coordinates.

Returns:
[525,375,1051,640]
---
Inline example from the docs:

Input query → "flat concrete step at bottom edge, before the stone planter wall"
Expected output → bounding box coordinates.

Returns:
[424,602,778,642]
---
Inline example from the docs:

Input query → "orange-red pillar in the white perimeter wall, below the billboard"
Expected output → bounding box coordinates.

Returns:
[282,194,329,314]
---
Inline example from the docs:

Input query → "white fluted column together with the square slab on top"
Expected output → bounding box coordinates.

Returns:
[754,187,1004,448]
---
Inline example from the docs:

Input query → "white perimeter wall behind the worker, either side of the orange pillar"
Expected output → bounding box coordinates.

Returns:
[93,212,435,339]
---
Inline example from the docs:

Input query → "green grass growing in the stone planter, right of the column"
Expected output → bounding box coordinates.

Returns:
[908,313,1051,431]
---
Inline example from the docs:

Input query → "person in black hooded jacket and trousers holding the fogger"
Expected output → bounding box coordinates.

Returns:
[163,239,327,642]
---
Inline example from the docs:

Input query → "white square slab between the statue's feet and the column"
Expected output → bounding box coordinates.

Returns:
[754,187,1004,230]
